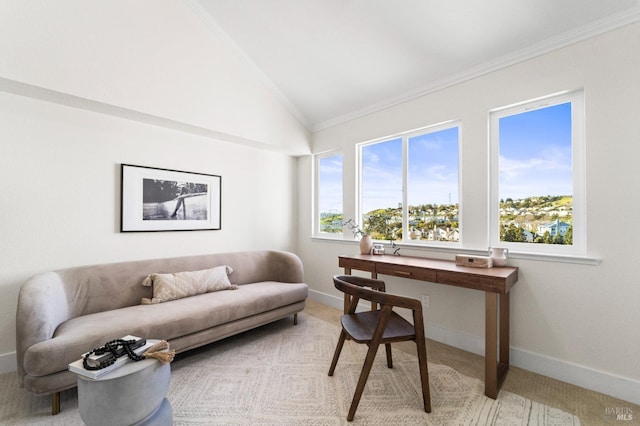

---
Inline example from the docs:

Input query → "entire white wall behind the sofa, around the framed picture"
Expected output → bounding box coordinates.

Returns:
[0,1,309,373]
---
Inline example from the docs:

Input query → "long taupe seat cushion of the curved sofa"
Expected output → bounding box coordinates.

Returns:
[24,281,308,376]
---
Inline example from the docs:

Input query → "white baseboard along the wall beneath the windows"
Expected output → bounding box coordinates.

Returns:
[309,289,640,404]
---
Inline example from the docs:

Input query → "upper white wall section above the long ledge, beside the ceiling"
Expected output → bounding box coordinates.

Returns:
[0,0,308,154]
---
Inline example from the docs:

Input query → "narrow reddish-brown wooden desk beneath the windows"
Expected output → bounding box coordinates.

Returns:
[338,255,518,399]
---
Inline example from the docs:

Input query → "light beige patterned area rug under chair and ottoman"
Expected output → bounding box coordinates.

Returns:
[0,313,580,426]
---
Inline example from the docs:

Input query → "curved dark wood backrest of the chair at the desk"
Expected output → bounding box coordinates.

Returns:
[333,275,422,316]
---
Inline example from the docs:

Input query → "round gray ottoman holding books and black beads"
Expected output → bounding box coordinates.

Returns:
[78,350,173,426]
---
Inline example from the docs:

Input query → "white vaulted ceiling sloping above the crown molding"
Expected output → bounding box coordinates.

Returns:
[192,0,640,131]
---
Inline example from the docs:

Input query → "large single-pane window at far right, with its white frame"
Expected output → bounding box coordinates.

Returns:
[490,92,585,255]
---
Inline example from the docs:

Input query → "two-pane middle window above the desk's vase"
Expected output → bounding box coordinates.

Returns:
[359,123,460,245]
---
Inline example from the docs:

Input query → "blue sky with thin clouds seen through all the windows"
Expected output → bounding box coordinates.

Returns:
[318,103,573,212]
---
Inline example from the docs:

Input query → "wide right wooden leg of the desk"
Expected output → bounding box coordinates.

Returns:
[484,292,509,399]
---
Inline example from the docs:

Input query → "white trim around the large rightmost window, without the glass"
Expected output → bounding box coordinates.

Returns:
[488,90,587,261]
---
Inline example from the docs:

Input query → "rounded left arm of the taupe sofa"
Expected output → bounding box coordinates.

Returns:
[16,272,70,385]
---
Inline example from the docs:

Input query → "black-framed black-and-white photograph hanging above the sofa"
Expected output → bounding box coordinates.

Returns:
[120,164,222,232]
